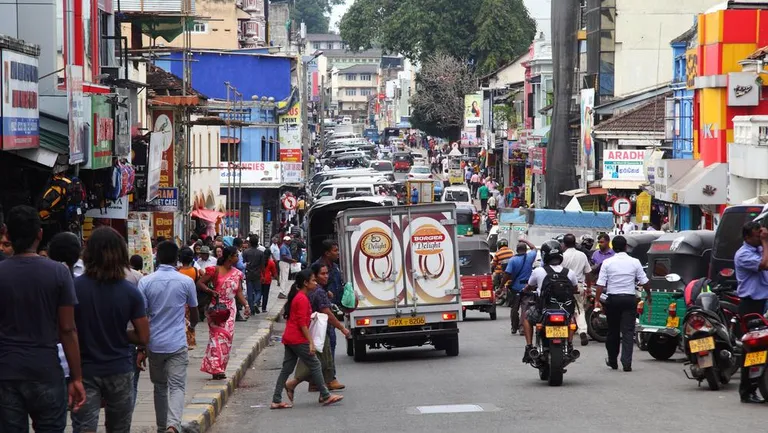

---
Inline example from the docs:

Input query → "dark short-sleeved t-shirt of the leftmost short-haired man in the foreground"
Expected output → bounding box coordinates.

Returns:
[0,256,77,382]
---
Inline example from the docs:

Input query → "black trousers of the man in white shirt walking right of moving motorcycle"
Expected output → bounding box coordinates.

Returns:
[605,295,637,366]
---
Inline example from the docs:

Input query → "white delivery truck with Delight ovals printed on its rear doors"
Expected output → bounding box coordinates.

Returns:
[336,203,462,361]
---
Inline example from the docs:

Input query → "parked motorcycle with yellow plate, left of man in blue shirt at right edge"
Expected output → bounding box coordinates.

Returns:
[680,274,741,391]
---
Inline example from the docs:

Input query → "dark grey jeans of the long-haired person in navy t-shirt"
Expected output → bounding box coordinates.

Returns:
[72,372,134,433]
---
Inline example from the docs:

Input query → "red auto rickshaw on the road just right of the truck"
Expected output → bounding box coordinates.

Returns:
[458,238,496,320]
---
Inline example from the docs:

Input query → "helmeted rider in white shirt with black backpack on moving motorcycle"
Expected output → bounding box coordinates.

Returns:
[523,240,579,362]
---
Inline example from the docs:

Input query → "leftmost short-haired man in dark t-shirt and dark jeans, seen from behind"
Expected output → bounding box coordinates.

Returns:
[0,206,86,432]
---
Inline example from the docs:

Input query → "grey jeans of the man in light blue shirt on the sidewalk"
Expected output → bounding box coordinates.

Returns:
[149,347,189,433]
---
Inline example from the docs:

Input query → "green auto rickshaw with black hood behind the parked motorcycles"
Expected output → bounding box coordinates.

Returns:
[635,230,715,360]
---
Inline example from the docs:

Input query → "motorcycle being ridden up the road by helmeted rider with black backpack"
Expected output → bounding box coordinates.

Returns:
[528,299,580,386]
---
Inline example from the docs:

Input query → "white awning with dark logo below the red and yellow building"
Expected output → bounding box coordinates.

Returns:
[668,161,728,205]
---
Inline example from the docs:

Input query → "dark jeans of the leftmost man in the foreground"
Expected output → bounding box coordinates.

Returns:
[0,374,67,433]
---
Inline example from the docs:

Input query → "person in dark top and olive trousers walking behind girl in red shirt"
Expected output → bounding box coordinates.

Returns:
[285,263,350,392]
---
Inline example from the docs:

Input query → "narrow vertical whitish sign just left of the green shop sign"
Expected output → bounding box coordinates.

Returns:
[66,65,85,164]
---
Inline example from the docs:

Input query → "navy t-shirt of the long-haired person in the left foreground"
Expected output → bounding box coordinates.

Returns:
[75,275,147,377]
